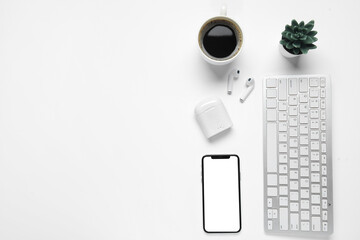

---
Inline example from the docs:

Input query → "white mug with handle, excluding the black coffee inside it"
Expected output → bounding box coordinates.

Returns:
[198,6,244,65]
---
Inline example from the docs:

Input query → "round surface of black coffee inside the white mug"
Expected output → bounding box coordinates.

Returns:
[203,24,237,58]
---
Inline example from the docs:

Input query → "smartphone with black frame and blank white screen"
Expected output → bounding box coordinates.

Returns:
[202,155,241,233]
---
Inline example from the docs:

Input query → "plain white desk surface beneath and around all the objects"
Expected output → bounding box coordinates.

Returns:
[0,0,360,240]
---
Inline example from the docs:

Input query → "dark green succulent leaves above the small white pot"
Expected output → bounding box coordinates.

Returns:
[280,19,317,55]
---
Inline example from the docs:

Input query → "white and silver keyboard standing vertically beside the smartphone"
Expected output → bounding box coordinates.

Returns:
[263,75,333,235]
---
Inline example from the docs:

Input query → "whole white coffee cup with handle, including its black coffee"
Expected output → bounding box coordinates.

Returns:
[198,6,244,65]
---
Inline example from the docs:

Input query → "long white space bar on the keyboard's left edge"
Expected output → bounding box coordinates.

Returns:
[266,122,277,172]
